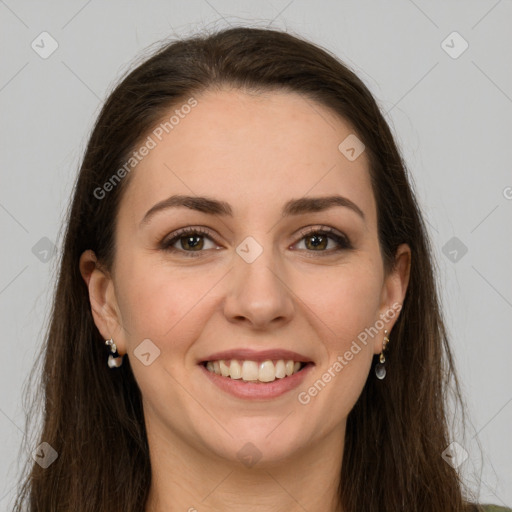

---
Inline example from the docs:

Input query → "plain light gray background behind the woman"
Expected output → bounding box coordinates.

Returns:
[0,0,512,510]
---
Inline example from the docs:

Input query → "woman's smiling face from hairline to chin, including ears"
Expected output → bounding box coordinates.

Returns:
[82,90,408,464]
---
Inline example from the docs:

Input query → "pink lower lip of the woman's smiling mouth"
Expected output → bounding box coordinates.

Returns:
[199,363,314,400]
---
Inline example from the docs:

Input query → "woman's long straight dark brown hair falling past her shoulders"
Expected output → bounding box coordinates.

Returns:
[15,27,484,512]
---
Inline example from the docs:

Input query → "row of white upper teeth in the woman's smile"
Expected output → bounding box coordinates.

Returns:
[206,359,302,382]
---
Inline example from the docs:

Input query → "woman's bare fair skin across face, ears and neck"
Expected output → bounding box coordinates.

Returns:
[80,89,410,512]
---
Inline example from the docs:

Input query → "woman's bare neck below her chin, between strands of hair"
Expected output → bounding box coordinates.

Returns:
[145,418,345,512]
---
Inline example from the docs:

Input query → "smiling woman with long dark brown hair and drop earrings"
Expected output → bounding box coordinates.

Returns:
[16,28,504,512]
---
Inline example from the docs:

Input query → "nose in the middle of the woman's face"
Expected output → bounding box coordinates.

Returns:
[224,241,294,330]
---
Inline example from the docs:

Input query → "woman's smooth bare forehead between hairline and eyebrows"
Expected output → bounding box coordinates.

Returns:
[121,89,375,228]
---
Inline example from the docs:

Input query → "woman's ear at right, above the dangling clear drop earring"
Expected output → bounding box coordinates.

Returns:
[374,244,411,354]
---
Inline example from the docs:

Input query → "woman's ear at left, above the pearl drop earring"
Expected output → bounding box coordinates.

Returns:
[79,250,126,355]
